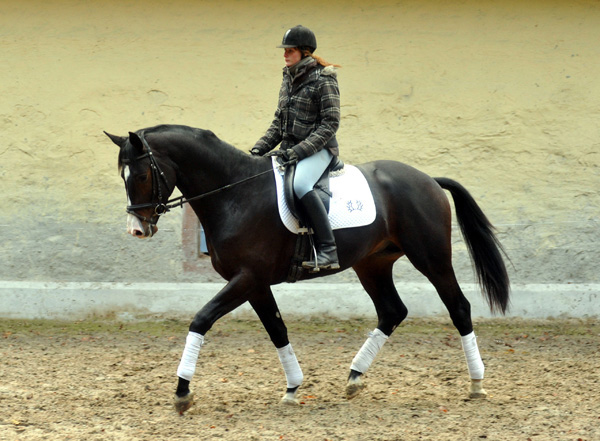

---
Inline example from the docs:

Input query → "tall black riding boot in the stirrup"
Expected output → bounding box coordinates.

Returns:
[300,190,340,271]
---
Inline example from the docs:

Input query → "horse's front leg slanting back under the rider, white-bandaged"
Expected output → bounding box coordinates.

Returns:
[250,287,304,404]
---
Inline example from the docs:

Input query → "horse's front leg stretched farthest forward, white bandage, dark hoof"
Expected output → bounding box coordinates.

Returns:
[175,276,252,414]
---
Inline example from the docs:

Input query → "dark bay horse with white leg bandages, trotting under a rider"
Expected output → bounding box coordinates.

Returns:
[105,125,510,414]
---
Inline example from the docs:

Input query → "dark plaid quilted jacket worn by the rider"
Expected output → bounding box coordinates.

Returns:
[254,60,340,159]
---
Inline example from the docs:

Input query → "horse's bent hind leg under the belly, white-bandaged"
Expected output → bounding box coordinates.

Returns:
[346,255,408,399]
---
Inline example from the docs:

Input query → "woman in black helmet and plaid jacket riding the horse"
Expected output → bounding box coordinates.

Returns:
[251,25,340,270]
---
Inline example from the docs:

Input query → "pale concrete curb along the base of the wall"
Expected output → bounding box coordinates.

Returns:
[0,281,600,320]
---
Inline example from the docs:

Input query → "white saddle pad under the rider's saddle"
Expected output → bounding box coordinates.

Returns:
[273,157,376,234]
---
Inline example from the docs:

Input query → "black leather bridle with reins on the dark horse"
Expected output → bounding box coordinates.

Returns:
[121,132,287,226]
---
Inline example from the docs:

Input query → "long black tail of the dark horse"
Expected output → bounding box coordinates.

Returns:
[434,178,510,314]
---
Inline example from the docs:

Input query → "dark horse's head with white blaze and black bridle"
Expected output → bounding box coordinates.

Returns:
[104,132,175,239]
